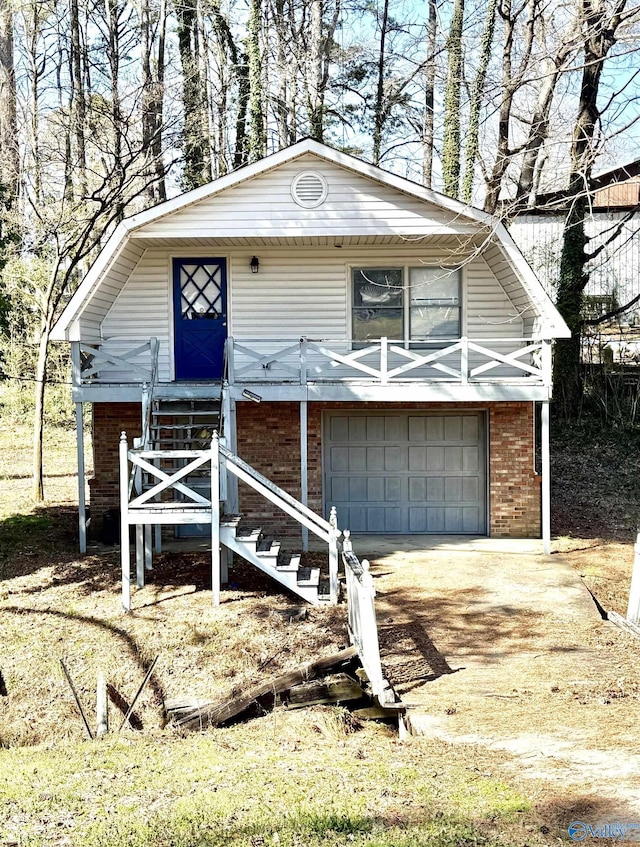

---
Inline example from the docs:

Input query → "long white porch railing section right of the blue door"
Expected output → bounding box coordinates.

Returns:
[227,338,551,385]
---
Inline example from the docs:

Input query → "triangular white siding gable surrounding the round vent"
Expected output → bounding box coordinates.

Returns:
[135,154,477,238]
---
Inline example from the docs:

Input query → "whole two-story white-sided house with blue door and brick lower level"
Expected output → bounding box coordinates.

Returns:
[53,140,569,604]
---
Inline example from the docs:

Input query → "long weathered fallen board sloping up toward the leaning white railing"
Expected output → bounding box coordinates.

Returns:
[175,647,358,729]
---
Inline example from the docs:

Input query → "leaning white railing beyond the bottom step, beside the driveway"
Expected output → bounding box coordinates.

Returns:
[342,530,394,706]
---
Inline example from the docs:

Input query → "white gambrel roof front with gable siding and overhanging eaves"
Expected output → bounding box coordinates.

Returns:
[52,139,570,341]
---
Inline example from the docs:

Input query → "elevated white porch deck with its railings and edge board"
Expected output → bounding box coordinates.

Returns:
[67,337,551,402]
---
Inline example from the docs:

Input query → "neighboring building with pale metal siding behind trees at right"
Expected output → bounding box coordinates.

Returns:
[509,160,640,317]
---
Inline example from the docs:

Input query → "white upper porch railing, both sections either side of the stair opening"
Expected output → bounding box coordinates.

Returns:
[72,337,551,386]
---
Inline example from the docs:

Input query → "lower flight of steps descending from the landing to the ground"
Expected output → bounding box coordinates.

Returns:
[220,515,331,606]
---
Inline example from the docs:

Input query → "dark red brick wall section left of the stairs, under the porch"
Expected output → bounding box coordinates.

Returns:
[89,403,142,533]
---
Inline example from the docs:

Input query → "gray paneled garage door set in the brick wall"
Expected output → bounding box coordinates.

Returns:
[324,412,486,535]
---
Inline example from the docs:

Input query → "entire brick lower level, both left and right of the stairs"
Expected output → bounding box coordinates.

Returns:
[90,403,540,538]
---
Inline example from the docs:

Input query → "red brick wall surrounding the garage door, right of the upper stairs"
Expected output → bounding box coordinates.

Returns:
[237,403,540,538]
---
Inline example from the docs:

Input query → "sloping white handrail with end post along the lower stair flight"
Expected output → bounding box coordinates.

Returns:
[218,434,341,604]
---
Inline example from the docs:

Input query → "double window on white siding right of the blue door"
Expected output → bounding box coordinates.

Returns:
[352,265,462,341]
